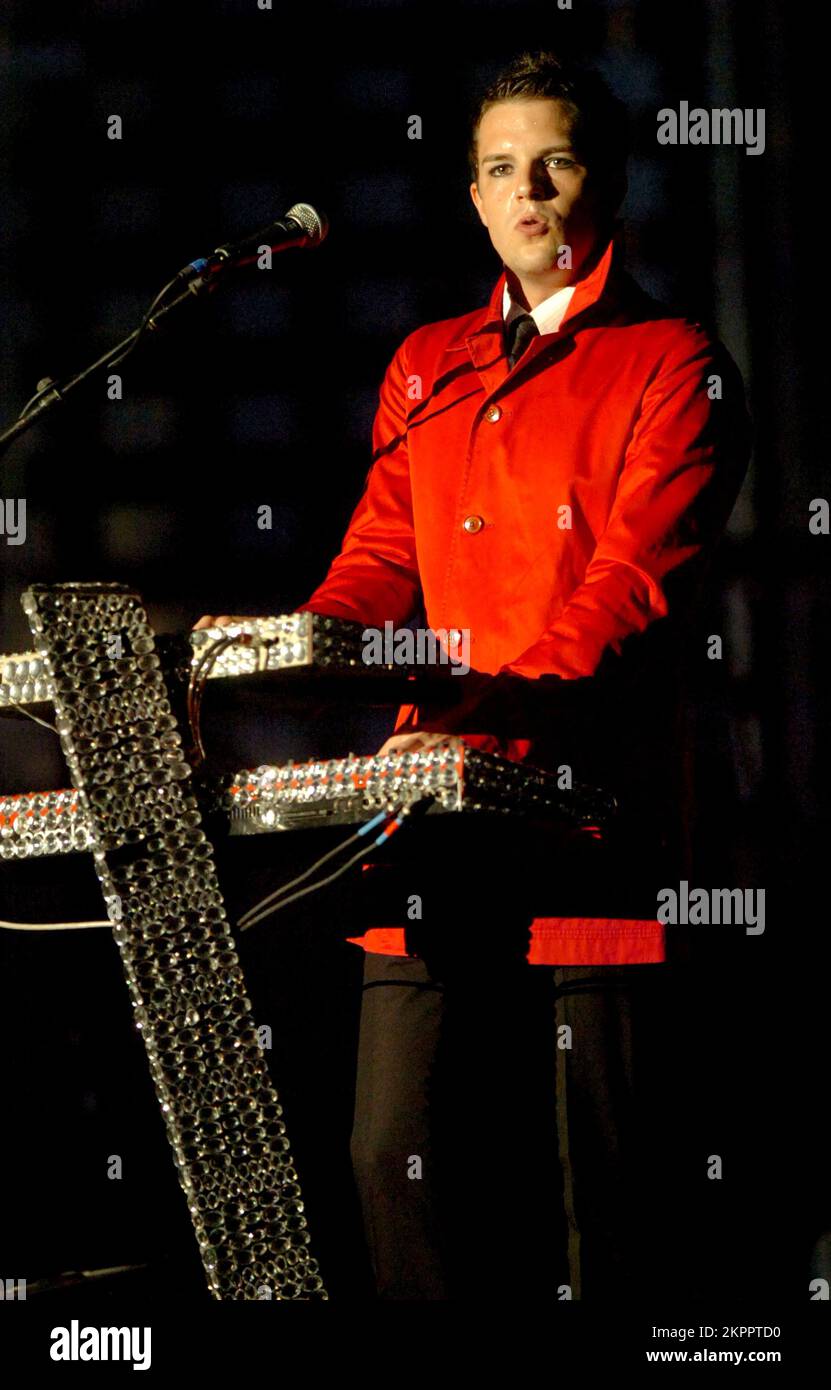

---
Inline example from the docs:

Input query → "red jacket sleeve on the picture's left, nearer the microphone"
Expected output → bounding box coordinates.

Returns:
[299,339,421,627]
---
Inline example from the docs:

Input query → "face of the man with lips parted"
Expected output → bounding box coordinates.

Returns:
[470,97,609,309]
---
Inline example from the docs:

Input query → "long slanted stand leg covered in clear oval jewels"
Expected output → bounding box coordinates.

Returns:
[24,584,327,1300]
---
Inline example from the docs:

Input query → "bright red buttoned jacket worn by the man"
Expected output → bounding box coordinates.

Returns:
[303,227,749,965]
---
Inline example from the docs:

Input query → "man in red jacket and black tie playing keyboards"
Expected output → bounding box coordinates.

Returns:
[197,54,749,1300]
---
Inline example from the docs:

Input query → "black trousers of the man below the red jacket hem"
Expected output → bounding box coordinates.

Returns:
[352,949,668,1301]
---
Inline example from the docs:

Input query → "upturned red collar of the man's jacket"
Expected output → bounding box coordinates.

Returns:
[458,221,624,392]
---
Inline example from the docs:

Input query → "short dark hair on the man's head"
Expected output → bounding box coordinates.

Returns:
[468,53,630,183]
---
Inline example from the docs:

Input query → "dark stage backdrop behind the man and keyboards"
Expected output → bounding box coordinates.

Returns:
[0,0,831,1301]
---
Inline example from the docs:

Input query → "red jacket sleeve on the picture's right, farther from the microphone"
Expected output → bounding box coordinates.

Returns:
[500,329,750,678]
